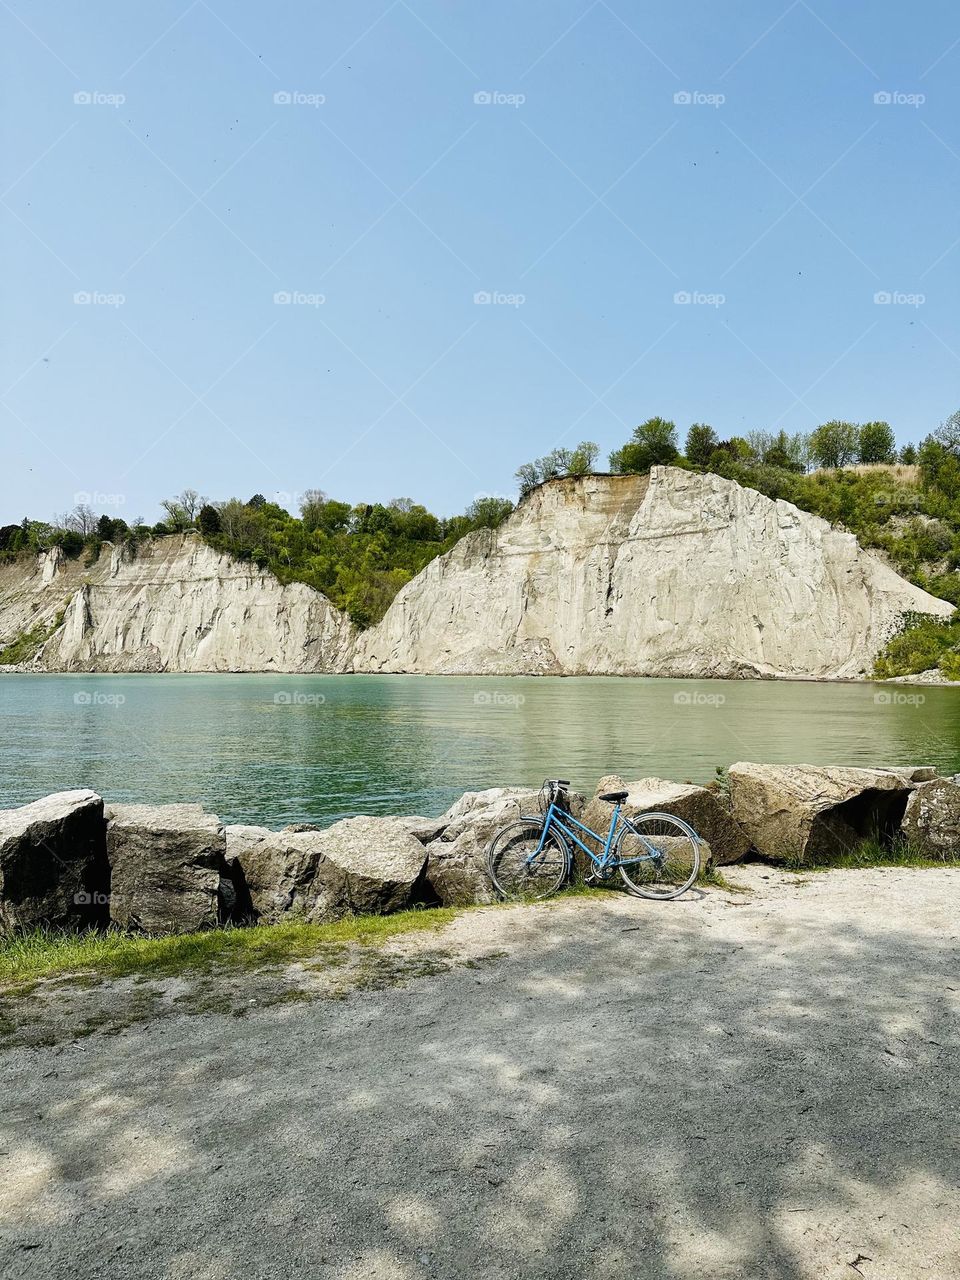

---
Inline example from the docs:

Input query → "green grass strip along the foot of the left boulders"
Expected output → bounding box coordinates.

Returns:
[0,906,458,993]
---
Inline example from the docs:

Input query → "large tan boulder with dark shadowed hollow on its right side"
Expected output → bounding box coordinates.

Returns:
[730,762,913,863]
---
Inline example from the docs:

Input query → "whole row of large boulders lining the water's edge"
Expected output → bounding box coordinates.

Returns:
[0,762,960,934]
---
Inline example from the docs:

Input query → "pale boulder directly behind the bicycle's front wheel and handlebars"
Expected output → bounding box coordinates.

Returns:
[426,787,584,906]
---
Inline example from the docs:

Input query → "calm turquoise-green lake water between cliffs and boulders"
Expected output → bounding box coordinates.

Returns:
[0,675,960,826]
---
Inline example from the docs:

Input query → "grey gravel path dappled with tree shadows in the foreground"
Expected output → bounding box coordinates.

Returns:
[0,868,960,1280]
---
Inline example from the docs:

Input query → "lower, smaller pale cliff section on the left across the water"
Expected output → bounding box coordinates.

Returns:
[0,534,355,672]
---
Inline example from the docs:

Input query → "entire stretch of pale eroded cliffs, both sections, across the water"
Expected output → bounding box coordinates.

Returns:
[0,467,952,678]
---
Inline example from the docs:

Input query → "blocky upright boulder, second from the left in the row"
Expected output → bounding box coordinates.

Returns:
[106,804,229,933]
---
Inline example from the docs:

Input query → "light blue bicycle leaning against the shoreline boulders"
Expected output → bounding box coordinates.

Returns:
[486,778,700,902]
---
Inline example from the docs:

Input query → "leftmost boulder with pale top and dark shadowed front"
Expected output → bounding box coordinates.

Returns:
[0,790,109,929]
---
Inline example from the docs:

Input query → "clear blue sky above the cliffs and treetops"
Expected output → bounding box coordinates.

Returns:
[0,0,960,522]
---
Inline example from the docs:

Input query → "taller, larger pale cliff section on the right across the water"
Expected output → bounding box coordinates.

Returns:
[353,467,952,677]
